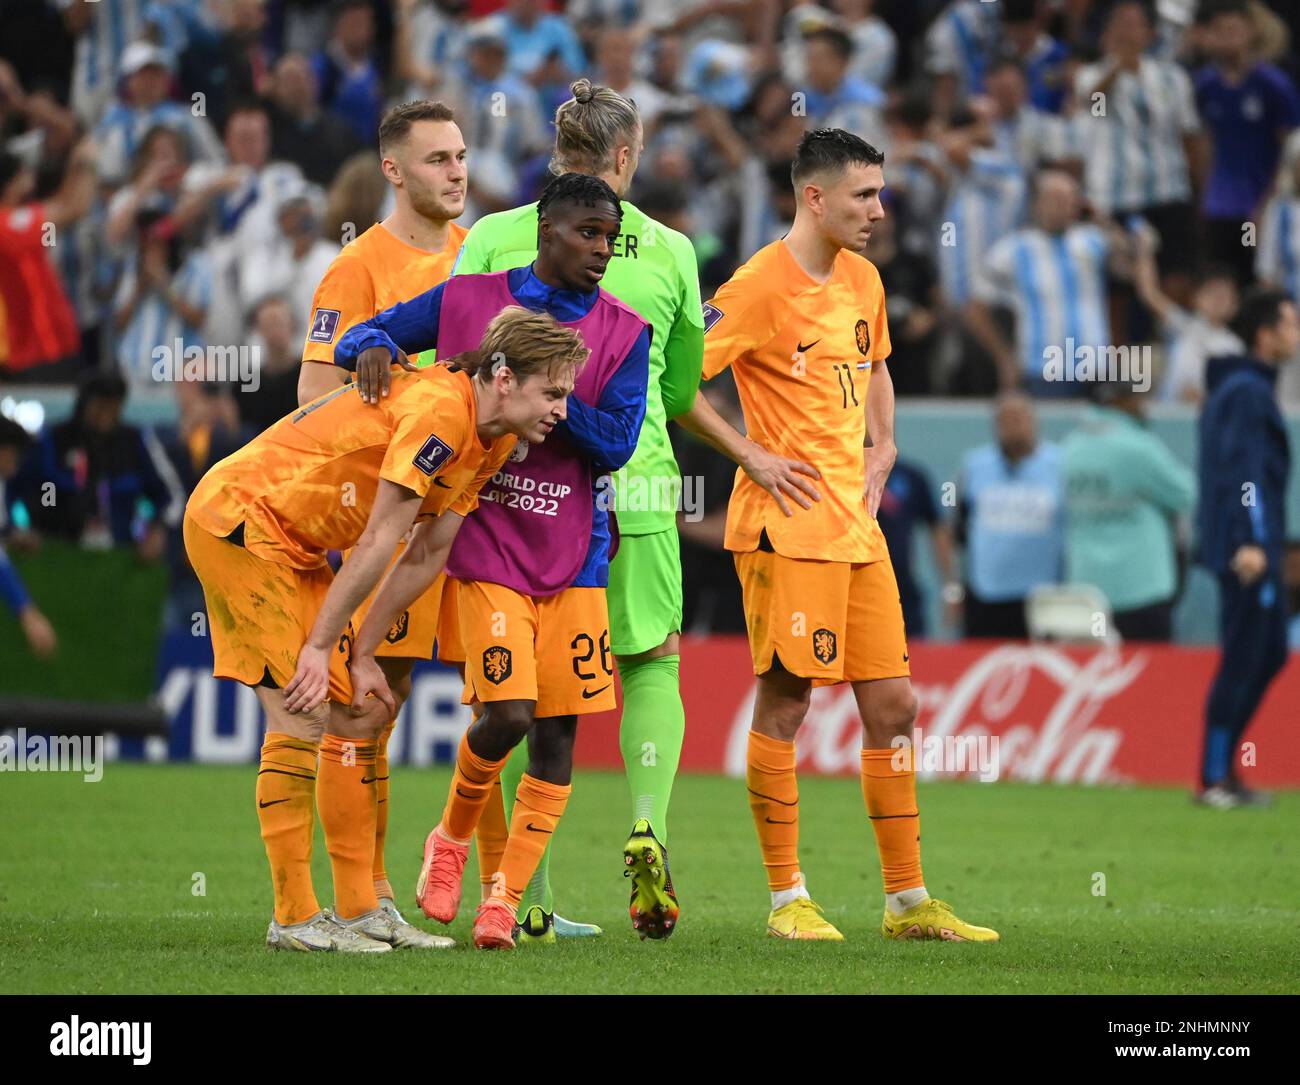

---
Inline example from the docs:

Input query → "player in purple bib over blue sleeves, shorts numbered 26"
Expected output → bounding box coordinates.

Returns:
[335,173,650,949]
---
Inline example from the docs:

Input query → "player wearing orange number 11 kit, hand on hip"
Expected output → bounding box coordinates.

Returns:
[681,129,997,942]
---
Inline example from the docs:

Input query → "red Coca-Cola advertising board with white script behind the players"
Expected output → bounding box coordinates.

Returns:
[576,637,1300,787]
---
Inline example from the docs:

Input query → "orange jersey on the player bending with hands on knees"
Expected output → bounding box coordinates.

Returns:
[186,365,515,569]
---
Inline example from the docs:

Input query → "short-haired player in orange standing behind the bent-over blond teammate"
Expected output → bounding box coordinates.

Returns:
[298,101,478,923]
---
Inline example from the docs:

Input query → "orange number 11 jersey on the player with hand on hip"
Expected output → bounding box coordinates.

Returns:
[703,240,889,561]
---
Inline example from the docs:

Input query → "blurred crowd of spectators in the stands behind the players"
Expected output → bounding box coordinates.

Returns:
[0,0,1300,657]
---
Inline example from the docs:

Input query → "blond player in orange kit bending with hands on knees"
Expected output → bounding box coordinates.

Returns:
[185,307,588,952]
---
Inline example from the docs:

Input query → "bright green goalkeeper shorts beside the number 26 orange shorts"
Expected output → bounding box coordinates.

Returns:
[607,528,681,655]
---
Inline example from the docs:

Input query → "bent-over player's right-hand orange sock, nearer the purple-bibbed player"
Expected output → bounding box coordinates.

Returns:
[316,734,380,919]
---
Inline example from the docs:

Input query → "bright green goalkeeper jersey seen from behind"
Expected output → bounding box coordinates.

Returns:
[451,200,705,535]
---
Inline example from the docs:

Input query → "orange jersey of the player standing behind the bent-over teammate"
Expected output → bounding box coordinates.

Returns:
[303,222,469,365]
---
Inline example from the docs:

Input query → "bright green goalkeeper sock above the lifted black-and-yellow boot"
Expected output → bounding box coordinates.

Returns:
[619,655,686,843]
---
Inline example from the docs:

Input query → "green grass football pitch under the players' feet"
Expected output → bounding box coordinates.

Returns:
[0,764,1300,993]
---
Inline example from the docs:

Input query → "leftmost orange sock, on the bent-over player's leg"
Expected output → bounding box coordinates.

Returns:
[256,732,321,926]
